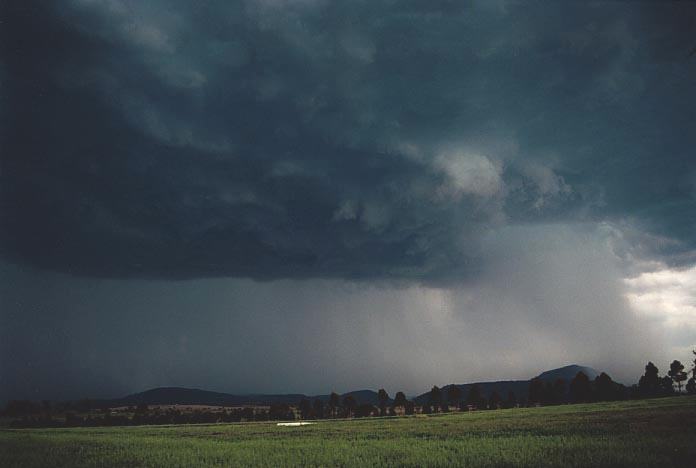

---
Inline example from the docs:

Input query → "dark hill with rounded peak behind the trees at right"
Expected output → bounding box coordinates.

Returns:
[414,364,599,404]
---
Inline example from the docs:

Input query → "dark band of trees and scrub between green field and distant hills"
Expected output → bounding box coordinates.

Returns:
[4,351,696,427]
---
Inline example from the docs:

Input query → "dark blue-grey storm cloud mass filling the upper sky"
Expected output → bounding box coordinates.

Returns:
[0,0,696,280]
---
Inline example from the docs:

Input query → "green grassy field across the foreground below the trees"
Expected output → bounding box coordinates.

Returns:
[0,397,696,467]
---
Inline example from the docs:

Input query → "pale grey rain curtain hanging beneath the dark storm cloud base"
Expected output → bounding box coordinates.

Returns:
[0,225,660,400]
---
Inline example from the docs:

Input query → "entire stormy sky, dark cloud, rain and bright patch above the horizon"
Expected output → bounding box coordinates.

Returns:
[0,0,696,401]
